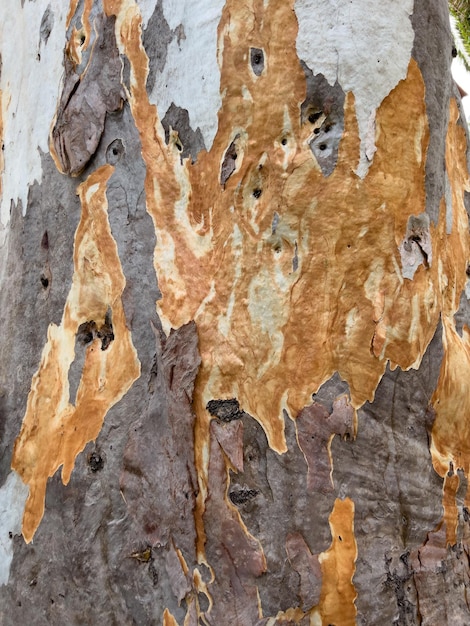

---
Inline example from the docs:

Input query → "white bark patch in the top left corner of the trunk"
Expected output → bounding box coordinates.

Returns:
[0,0,68,229]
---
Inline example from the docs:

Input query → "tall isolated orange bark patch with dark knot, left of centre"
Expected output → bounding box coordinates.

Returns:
[12,165,140,542]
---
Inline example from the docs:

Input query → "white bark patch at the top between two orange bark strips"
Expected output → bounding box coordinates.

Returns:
[150,0,225,150]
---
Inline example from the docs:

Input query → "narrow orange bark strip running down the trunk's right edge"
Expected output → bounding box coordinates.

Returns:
[431,100,470,544]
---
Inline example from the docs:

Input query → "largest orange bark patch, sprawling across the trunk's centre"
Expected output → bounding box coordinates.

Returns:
[105,0,439,444]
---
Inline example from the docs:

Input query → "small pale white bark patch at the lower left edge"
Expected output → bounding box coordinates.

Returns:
[0,472,29,585]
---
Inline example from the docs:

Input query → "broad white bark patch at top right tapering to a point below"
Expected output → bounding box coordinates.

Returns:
[295,0,414,177]
